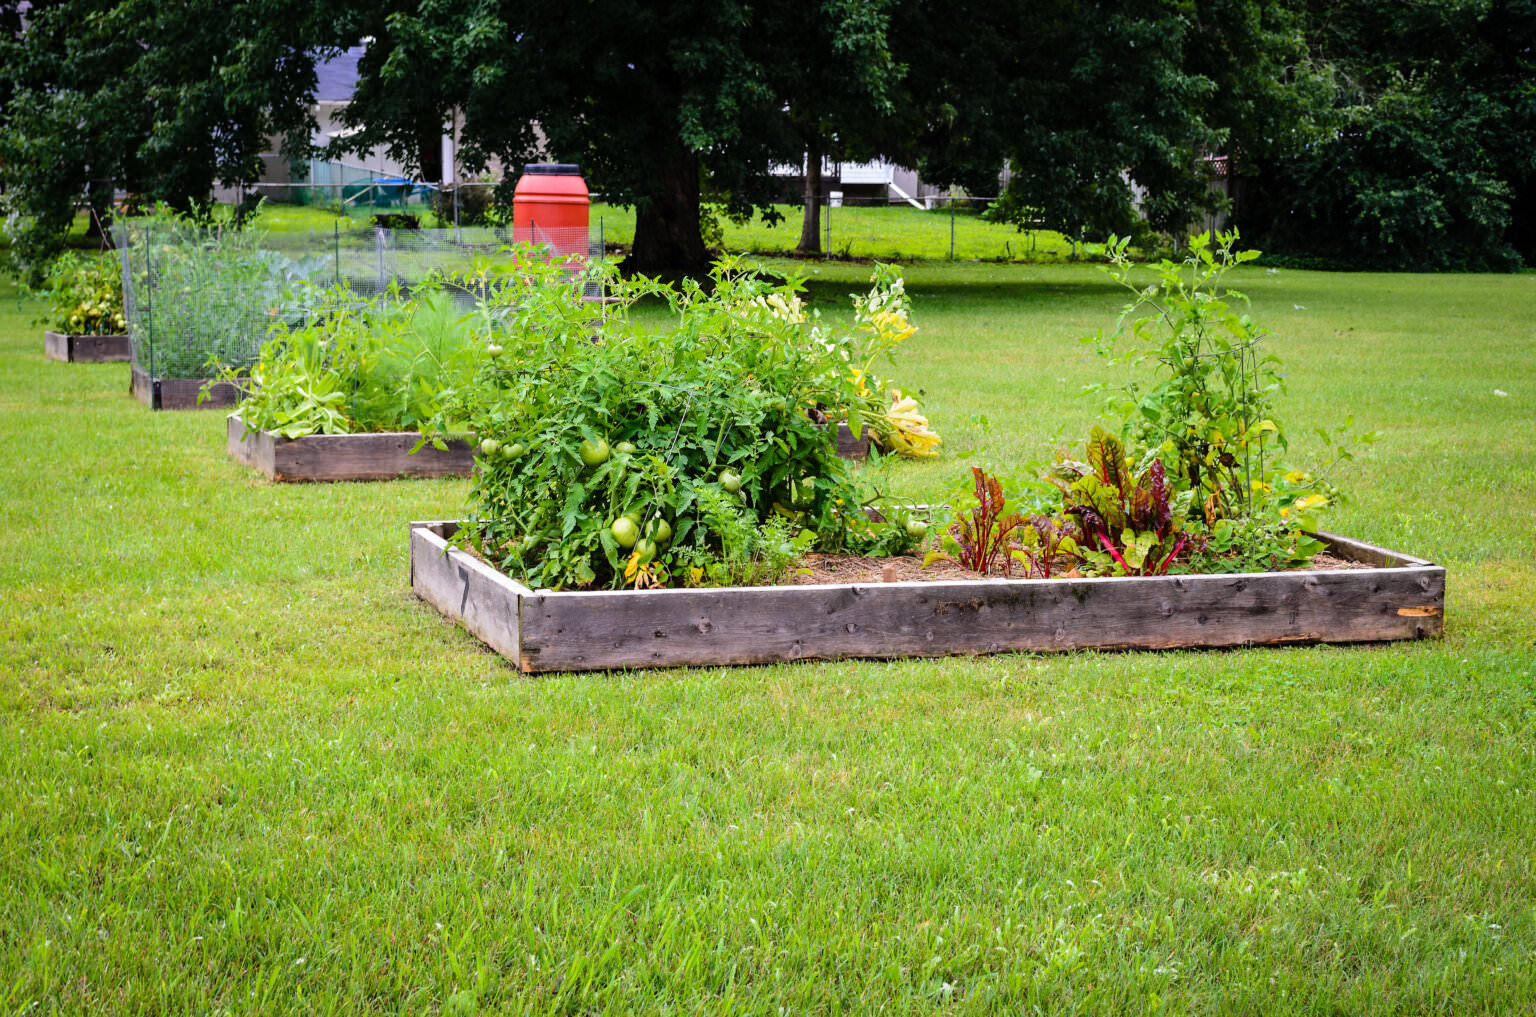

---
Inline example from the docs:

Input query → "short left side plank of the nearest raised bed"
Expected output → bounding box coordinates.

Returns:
[410,522,531,661]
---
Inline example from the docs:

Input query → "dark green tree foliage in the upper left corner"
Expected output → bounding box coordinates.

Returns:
[0,0,330,274]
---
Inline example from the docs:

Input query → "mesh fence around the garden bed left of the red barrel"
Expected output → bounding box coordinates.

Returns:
[114,220,602,378]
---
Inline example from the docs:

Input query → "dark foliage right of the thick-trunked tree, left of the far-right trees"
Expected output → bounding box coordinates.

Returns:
[892,0,1301,235]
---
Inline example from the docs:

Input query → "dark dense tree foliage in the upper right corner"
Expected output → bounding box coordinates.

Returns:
[1240,0,1536,270]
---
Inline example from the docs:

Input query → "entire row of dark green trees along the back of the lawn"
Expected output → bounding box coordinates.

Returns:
[0,0,1536,272]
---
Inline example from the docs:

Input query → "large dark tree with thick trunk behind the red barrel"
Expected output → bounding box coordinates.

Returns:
[336,0,899,273]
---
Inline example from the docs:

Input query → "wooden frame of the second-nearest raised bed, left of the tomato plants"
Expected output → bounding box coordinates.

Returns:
[229,416,475,481]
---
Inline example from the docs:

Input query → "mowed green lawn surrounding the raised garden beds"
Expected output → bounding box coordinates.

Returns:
[0,263,1536,1014]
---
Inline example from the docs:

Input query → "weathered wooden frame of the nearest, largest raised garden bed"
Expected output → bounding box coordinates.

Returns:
[410,522,1445,671]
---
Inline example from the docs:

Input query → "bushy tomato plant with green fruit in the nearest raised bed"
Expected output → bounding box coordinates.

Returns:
[458,252,914,588]
